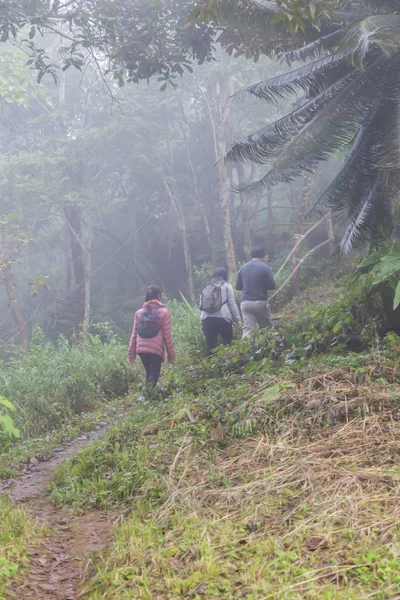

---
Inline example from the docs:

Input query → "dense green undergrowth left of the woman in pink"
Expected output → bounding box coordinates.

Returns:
[0,328,134,436]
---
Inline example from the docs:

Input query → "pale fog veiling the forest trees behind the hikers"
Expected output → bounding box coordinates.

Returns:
[0,37,340,353]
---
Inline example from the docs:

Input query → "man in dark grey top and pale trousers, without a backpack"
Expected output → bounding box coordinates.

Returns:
[236,247,275,337]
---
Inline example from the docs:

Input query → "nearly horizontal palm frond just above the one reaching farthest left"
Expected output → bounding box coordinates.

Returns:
[236,52,346,102]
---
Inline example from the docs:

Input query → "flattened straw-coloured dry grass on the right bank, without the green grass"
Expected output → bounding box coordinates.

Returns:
[150,372,400,598]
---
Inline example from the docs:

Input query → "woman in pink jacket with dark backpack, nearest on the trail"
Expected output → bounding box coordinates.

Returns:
[128,285,175,387]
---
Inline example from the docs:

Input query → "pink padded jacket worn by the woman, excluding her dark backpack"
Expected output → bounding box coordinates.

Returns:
[128,300,175,363]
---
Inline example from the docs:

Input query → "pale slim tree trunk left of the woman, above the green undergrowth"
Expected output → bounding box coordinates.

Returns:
[64,204,85,326]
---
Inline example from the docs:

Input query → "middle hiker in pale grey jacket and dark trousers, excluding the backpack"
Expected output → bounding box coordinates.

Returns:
[200,267,242,356]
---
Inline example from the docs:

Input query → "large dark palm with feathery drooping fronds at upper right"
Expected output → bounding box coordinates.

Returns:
[226,0,400,253]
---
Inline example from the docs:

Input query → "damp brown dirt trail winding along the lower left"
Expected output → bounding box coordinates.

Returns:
[0,427,116,600]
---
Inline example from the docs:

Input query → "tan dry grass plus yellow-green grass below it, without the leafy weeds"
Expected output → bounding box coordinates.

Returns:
[84,370,400,600]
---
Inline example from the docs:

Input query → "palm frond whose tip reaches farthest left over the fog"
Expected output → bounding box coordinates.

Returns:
[226,71,358,164]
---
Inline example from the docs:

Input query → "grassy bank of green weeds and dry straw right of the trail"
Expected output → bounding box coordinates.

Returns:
[44,280,400,600]
